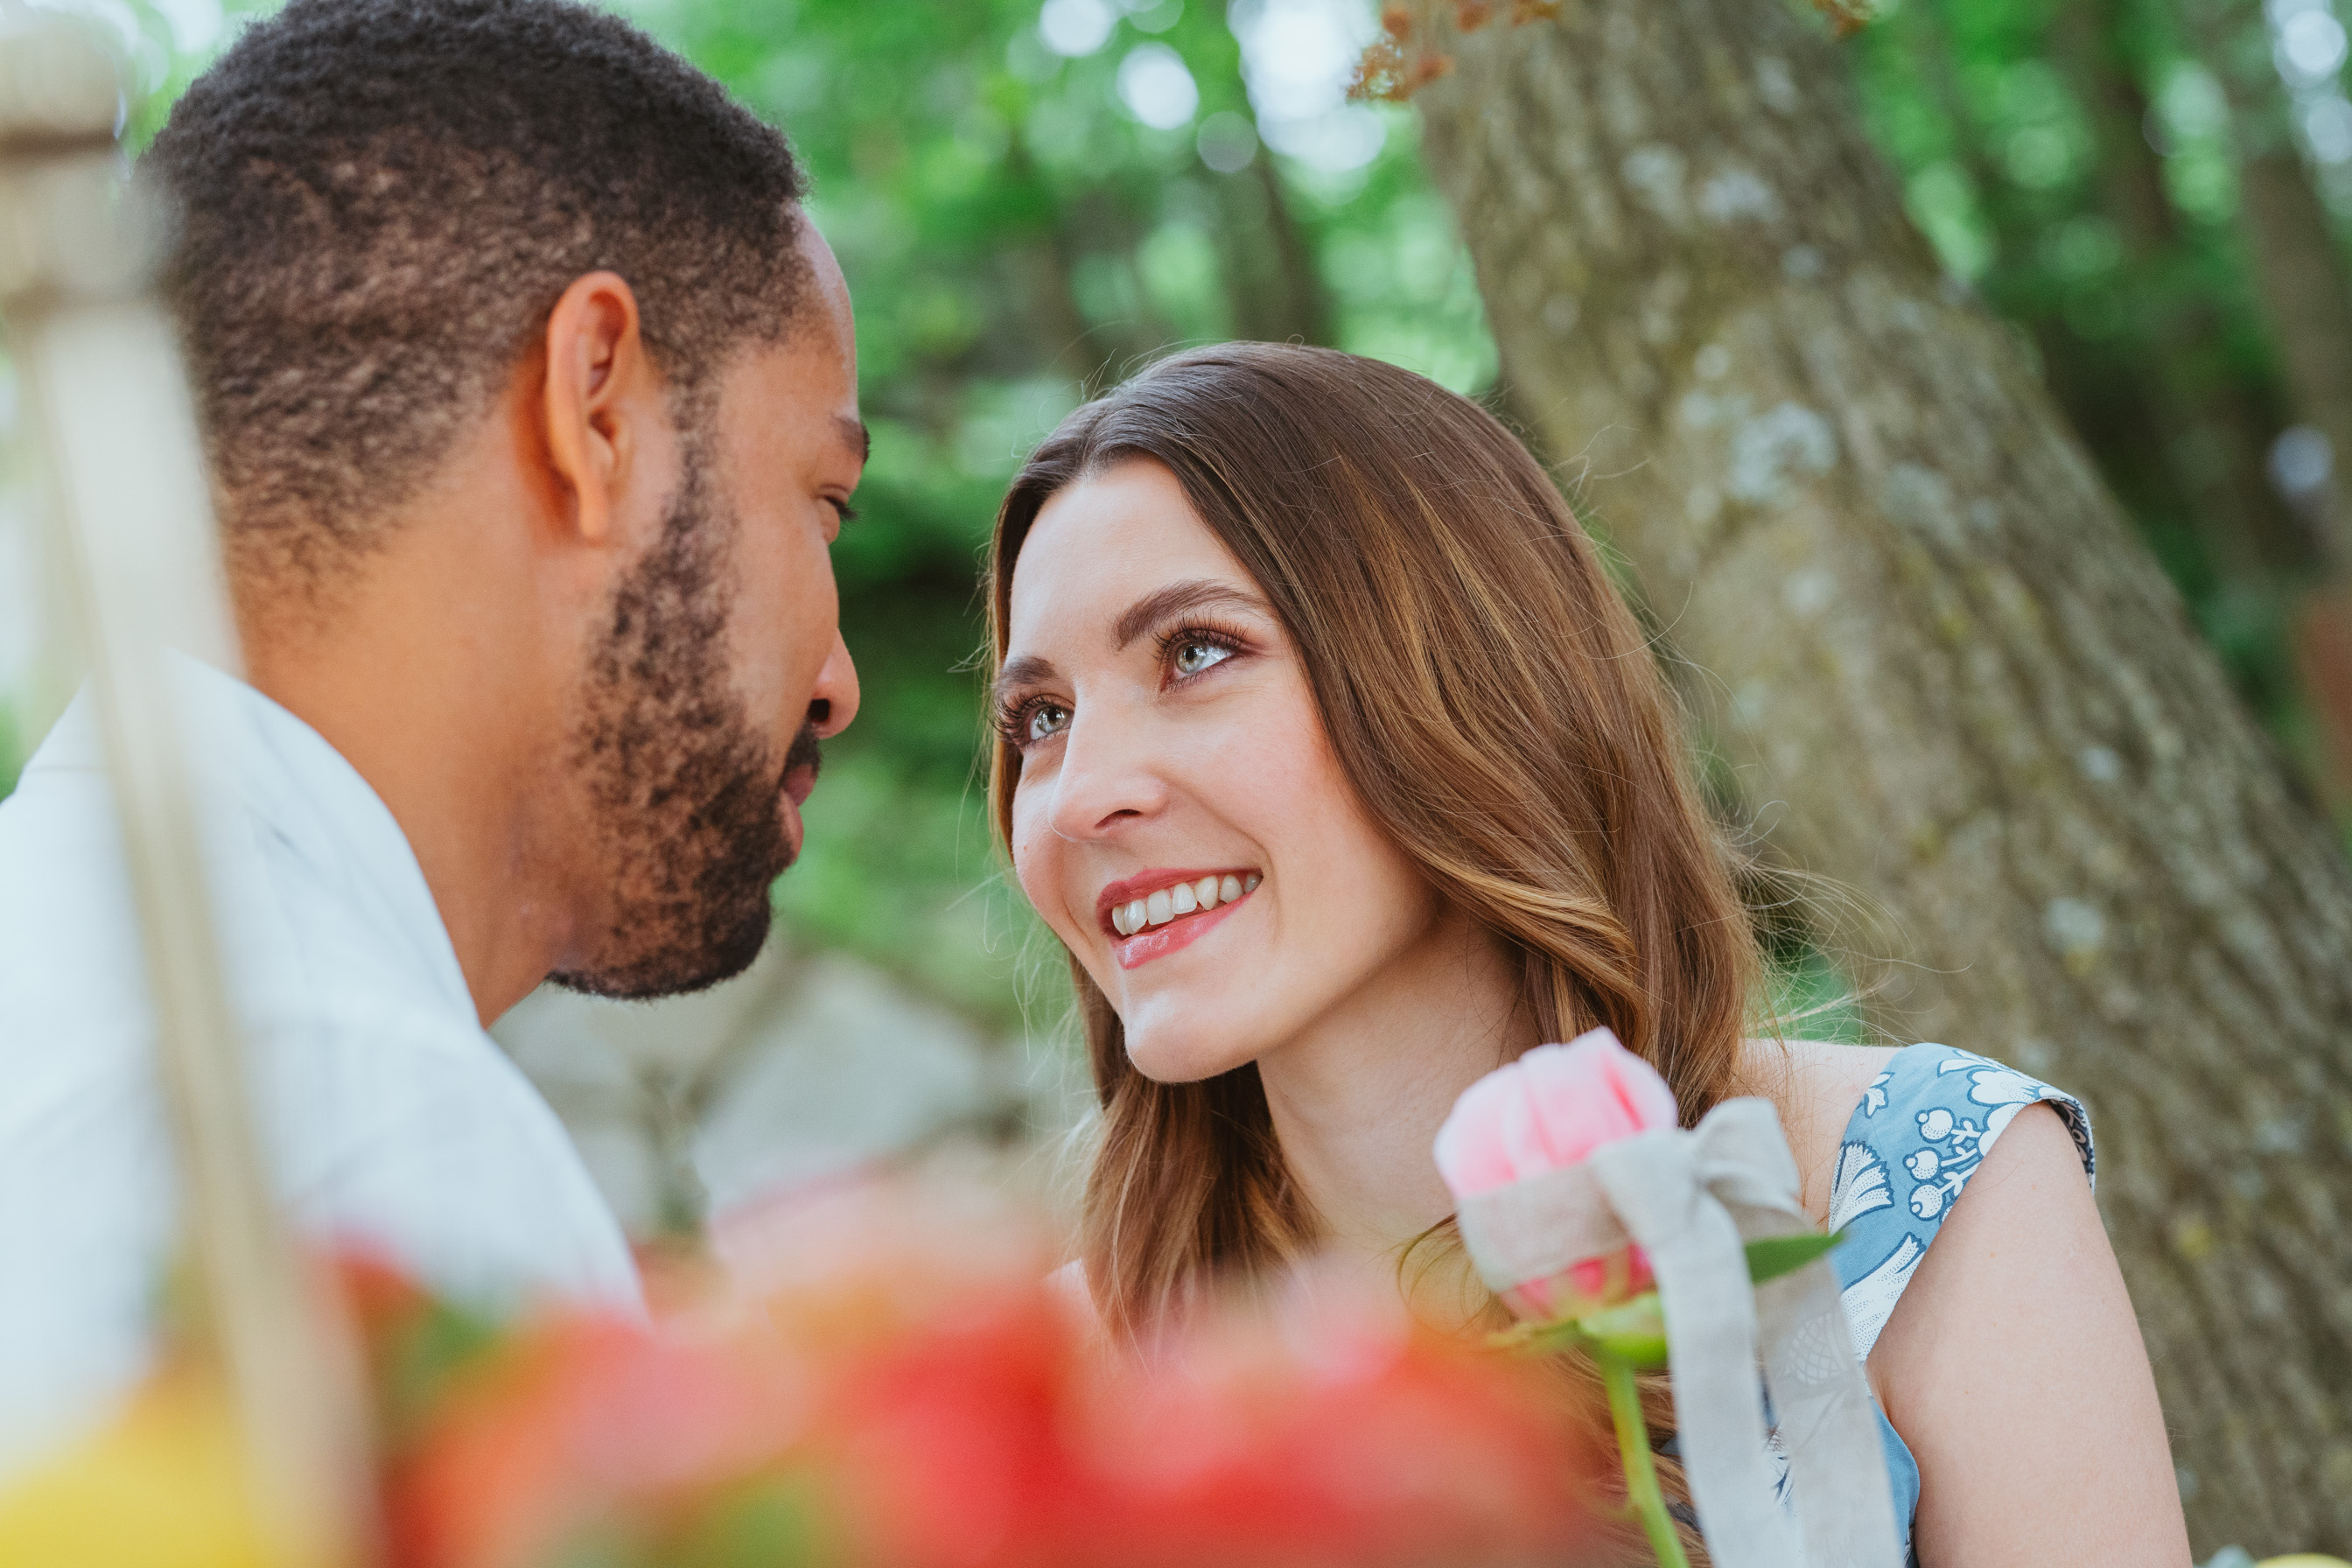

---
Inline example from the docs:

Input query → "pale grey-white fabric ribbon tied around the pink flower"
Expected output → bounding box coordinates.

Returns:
[1456,1100,1900,1568]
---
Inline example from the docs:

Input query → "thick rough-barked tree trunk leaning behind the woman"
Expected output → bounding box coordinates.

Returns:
[1418,0,2352,1551]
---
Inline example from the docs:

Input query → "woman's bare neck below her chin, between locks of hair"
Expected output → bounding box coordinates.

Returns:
[1258,914,1538,1257]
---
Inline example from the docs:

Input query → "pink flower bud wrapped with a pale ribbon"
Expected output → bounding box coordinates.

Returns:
[1432,1030,1677,1321]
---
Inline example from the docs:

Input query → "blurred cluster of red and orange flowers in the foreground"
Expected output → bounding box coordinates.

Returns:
[348,1175,1594,1568]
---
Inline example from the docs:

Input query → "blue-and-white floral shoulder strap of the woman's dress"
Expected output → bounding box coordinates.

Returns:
[1830,1044,2096,1359]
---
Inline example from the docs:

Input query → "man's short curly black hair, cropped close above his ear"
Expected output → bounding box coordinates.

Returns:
[146,0,809,576]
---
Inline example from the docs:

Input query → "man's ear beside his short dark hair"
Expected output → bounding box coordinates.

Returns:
[541,273,663,543]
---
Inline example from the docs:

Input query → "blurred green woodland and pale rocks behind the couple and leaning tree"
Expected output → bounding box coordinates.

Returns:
[0,0,2352,1234]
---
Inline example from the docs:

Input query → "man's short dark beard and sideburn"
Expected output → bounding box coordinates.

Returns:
[553,438,818,997]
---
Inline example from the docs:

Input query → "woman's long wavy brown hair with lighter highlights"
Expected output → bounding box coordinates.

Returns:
[988,343,1757,1333]
